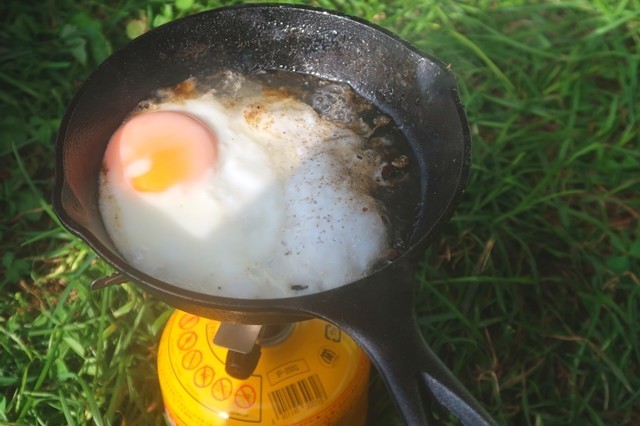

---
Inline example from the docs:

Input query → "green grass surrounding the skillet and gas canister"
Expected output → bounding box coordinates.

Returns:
[0,0,640,425]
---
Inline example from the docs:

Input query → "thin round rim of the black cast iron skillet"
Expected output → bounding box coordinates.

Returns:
[53,3,471,315]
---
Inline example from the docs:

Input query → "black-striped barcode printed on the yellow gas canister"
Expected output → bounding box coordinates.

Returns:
[269,374,327,418]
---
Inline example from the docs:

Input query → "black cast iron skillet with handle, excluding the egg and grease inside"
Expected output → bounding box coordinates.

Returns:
[53,5,493,425]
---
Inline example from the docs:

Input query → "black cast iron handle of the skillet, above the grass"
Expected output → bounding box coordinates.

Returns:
[308,268,496,426]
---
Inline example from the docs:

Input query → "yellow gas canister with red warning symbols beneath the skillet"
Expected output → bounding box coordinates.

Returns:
[158,310,370,426]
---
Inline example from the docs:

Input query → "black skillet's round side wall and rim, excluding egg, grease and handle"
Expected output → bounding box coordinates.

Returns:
[54,6,470,323]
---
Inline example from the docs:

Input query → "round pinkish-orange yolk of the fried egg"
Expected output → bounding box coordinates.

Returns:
[106,111,218,192]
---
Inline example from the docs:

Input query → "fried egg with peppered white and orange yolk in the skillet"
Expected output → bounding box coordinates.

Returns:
[100,80,389,298]
